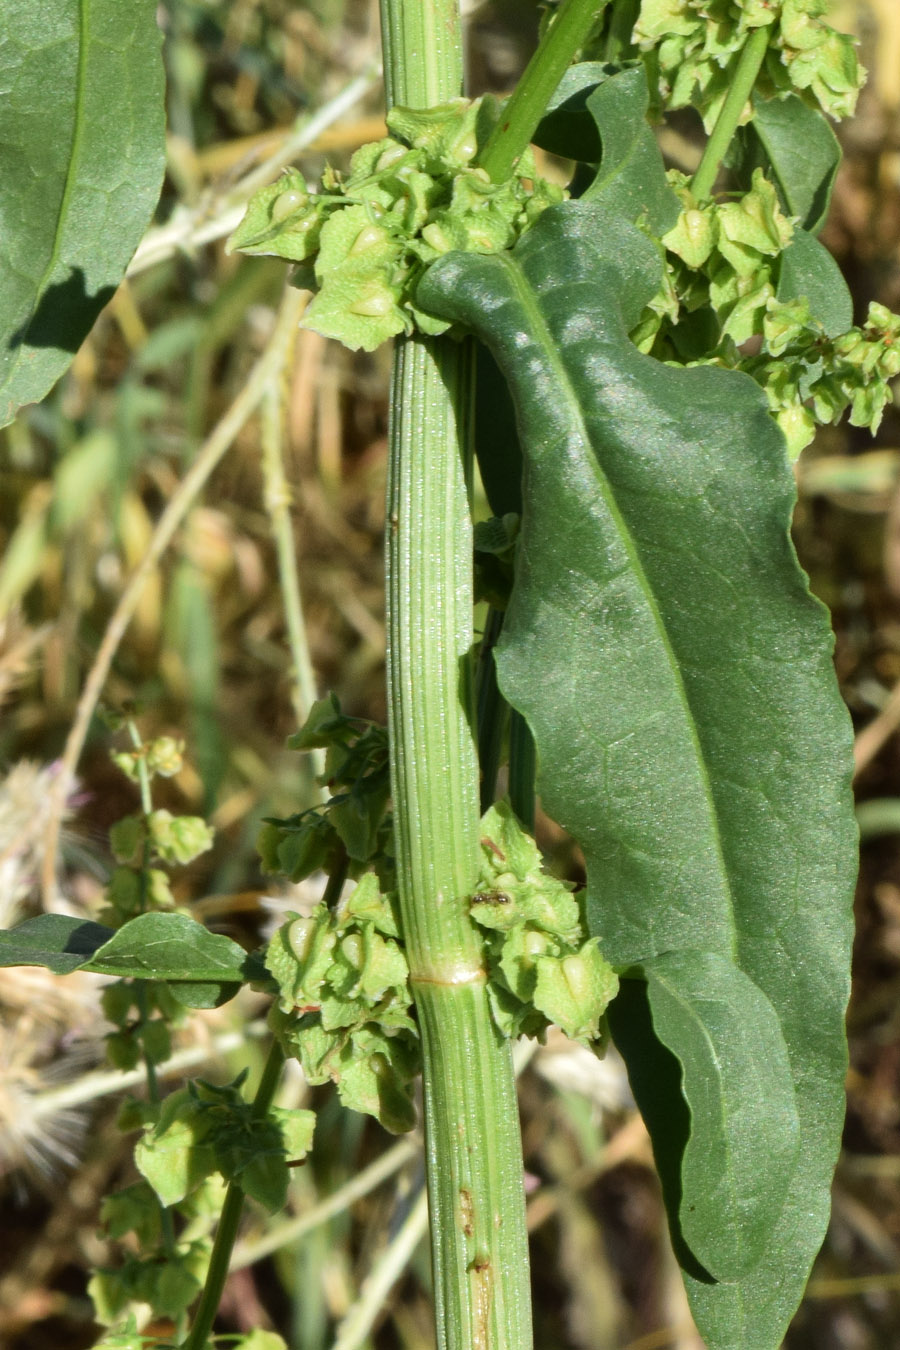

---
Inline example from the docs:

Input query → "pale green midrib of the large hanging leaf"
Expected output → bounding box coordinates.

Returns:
[495,245,739,965]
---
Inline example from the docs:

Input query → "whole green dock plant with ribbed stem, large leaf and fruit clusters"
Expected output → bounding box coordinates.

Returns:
[0,0,885,1350]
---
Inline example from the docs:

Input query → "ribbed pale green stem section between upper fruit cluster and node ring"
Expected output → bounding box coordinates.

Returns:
[387,340,482,983]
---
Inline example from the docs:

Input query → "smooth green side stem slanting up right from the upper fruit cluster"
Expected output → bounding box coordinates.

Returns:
[478,0,604,182]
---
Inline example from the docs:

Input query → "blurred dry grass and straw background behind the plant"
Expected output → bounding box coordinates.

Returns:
[0,0,900,1350]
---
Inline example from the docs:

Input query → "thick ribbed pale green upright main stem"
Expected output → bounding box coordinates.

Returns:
[382,0,532,1350]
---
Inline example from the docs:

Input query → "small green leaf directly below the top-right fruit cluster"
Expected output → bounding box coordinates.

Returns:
[743,93,841,235]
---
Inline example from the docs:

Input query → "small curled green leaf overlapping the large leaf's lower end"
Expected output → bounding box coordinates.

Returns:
[611,952,800,1280]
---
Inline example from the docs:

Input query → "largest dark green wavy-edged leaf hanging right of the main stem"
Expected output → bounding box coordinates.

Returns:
[420,203,855,1350]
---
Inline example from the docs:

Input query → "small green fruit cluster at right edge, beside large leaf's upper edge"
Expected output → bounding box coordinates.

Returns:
[739,300,900,458]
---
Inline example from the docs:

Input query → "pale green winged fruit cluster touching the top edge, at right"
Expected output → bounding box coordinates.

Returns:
[633,0,865,131]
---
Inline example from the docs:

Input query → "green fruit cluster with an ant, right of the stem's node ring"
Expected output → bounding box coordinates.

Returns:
[472,802,618,1049]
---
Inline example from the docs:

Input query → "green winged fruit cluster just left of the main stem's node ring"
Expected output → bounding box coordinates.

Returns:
[266,872,421,1134]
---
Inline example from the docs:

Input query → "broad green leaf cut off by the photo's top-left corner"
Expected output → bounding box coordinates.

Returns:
[0,0,165,427]
